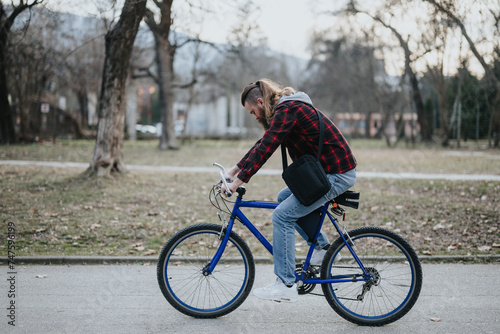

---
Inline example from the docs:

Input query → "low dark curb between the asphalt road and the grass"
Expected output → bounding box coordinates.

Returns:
[0,254,500,265]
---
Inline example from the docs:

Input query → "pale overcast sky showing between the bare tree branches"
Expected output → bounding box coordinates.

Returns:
[45,0,492,75]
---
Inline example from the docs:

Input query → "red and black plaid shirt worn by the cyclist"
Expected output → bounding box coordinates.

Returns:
[237,101,356,182]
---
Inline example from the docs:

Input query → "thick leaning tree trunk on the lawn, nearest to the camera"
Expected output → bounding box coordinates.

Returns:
[89,0,146,177]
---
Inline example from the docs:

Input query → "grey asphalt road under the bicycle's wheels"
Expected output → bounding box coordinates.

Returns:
[0,264,500,334]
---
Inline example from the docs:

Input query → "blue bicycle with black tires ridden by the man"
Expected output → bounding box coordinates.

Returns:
[157,164,422,326]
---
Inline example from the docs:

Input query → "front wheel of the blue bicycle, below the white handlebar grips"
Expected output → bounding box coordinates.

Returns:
[157,224,255,318]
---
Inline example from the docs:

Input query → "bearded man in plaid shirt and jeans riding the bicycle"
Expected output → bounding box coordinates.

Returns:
[222,79,356,302]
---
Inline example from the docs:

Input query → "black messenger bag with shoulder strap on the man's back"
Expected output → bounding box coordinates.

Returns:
[281,109,331,206]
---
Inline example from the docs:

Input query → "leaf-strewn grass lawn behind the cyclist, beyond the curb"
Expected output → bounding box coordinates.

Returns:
[0,140,500,256]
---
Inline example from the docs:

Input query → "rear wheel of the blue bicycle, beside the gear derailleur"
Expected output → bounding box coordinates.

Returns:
[321,227,422,326]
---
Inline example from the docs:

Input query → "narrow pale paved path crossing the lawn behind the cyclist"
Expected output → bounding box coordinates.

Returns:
[0,160,500,181]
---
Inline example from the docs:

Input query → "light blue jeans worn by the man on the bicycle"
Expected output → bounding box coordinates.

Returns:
[273,169,356,285]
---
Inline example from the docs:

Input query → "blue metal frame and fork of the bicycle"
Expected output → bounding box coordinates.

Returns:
[203,193,372,284]
